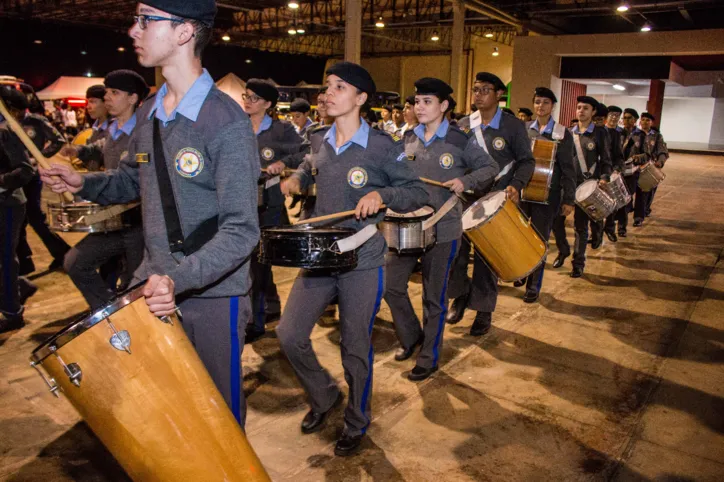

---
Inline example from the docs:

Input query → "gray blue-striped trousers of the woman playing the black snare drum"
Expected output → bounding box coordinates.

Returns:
[276,266,385,436]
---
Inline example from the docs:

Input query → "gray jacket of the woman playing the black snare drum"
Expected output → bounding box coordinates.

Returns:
[293,128,429,270]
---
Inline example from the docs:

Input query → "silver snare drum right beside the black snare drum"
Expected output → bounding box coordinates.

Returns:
[380,206,437,254]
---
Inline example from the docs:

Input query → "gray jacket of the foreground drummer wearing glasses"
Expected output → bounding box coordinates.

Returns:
[80,87,261,298]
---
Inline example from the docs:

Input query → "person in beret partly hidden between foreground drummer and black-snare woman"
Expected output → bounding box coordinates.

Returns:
[242,79,302,343]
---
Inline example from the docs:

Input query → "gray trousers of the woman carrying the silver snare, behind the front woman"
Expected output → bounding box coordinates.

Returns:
[385,239,460,368]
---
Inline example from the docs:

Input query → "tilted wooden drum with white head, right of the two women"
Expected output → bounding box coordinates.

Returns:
[463,191,548,281]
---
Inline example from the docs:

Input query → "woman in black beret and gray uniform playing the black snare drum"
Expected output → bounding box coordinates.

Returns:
[277,62,428,456]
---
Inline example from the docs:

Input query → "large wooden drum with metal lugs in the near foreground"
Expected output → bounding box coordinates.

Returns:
[30,286,270,482]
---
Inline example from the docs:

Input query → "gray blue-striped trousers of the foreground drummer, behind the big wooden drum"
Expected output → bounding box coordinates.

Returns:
[179,296,251,428]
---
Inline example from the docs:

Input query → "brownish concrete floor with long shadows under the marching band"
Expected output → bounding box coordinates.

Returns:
[0,154,724,482]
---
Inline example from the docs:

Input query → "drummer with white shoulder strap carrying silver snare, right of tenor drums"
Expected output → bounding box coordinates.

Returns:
[553,95,612,278]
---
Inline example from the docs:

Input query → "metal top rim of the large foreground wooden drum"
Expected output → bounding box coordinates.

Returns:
[30,281,146,363]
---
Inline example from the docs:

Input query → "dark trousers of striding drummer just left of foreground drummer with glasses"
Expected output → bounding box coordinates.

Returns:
[63,226,144,310]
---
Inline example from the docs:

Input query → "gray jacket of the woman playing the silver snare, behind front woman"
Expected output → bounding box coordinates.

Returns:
[403,126,499,243]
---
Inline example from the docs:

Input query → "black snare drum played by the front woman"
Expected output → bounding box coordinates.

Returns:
[259,227,357,270]
